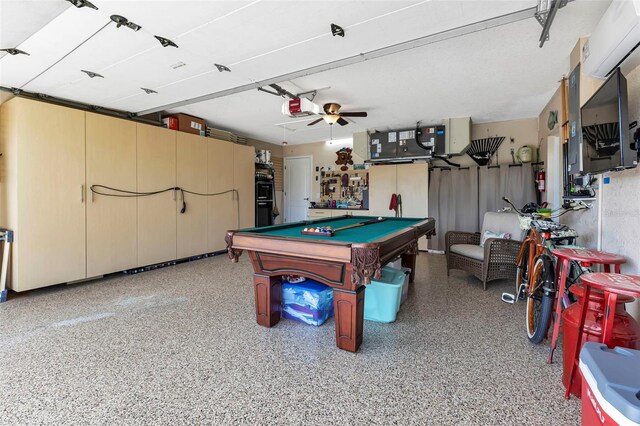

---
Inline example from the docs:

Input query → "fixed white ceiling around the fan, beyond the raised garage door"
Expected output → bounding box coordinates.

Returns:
[170,1,607,143]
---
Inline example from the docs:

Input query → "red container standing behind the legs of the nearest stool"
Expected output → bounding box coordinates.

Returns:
[562,284,640,398]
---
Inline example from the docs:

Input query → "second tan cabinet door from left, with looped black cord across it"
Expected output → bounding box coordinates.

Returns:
[86,113,138,277]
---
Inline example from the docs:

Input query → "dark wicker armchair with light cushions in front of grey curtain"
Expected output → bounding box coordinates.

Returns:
[444,212,524,290]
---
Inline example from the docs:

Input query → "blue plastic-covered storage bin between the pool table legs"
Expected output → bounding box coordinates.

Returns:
[282,279,333,326]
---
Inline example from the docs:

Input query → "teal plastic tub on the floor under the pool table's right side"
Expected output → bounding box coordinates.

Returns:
[364,267,405,323]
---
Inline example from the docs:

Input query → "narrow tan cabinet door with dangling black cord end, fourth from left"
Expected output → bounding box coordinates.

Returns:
[177,132,207,259]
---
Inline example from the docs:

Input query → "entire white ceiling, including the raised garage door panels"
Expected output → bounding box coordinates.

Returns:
[0,0,610,143]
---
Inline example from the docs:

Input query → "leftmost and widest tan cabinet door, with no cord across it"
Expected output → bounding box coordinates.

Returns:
[13,99,87,291]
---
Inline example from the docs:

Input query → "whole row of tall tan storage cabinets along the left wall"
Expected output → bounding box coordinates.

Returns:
[0,98,255,291]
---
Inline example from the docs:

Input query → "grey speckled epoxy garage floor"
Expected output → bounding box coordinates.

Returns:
[0,253,580,425]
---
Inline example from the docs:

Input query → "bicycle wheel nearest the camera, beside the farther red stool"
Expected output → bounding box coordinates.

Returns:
[526,256,555,344]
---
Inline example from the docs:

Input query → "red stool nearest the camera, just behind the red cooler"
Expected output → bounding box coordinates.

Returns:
[564,272,640,399]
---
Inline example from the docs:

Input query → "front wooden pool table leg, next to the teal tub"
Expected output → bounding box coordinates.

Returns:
[333,286,364,352]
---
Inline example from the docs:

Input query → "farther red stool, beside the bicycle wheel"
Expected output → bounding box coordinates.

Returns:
[547,248,627,364]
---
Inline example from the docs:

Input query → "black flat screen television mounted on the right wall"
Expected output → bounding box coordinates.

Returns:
[580,69,638,174]
